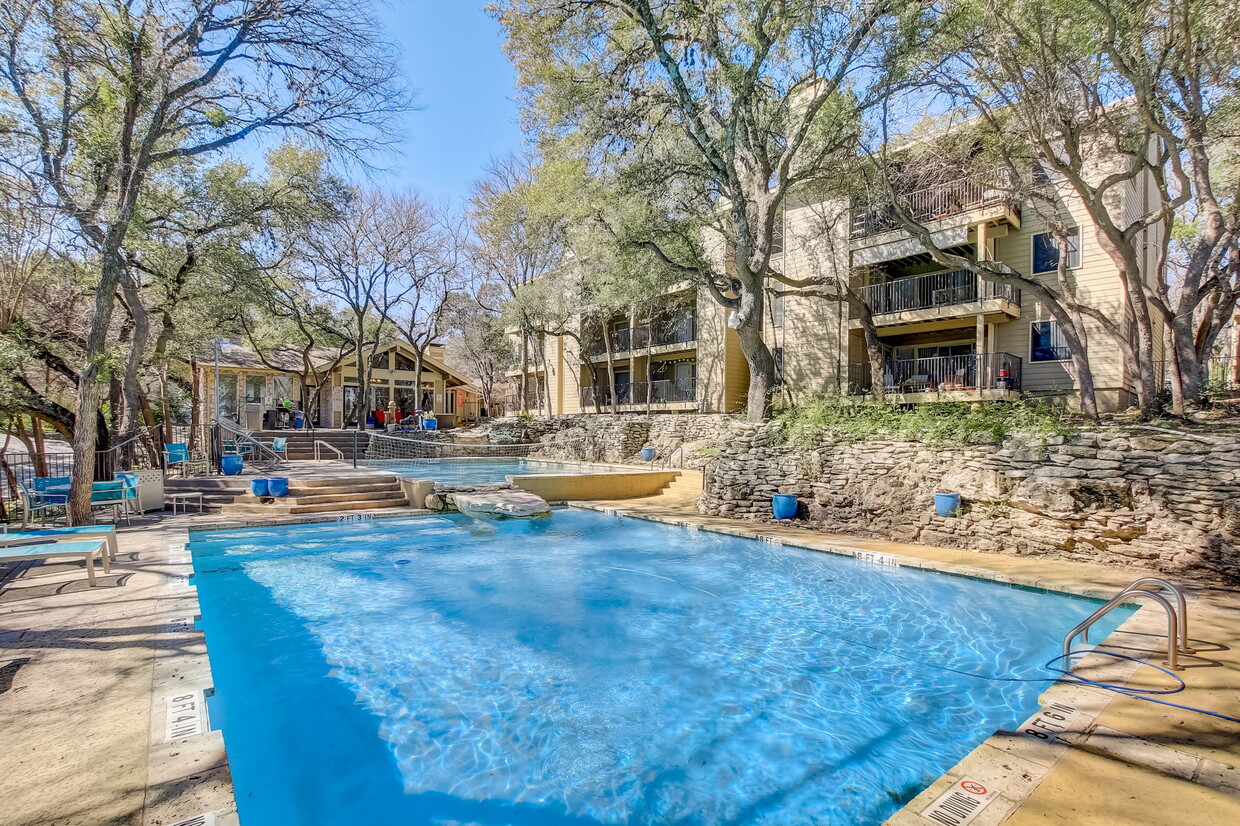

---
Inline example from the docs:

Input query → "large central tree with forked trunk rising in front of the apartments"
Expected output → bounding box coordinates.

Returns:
[492,0,919,419]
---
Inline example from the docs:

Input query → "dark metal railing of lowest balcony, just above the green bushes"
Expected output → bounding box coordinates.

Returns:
[848,352,1021,396]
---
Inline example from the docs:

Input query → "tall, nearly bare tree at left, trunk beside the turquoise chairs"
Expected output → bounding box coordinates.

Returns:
[0,0,404,515]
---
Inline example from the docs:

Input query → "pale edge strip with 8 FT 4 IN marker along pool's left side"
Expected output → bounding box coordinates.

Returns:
[143,527,239,826]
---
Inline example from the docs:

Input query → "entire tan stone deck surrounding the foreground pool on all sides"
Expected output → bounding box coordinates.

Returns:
[0,490,1240,826]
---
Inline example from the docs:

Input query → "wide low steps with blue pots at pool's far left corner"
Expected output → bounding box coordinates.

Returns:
[164,474,409,516]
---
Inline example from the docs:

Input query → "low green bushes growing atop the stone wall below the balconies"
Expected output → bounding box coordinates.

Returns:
[779,396,1069,446]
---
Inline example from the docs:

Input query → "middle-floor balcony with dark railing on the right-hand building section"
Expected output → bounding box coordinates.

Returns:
[853,269,1021,326]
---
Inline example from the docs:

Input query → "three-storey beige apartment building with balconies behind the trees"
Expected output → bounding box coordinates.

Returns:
[508,159,1162,414]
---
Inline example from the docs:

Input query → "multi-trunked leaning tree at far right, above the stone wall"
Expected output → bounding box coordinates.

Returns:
[929,0,1240,413]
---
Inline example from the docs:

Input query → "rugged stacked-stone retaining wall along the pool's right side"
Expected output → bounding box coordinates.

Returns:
[699,422,1240,583]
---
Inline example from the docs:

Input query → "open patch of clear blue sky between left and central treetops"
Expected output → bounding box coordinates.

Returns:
[364,0,521,201]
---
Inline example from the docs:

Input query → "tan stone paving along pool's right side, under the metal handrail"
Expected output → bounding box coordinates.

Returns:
[570,497,1240,826]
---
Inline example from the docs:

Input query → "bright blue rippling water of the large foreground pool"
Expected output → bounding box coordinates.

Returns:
[191,510,1122,826]
